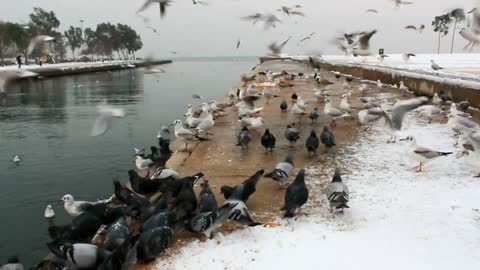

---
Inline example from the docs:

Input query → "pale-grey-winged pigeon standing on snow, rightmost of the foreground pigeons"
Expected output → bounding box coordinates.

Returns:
[325,168,350,212]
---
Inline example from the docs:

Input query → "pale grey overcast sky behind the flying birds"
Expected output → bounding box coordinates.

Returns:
[0,0,474,57]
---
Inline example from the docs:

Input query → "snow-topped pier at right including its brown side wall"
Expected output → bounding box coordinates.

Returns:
[313,54,480,108]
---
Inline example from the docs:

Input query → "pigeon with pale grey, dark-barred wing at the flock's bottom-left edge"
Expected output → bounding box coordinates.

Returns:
[47,241,100,269]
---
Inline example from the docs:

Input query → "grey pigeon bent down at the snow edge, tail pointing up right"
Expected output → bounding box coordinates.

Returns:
[190,203,237,238]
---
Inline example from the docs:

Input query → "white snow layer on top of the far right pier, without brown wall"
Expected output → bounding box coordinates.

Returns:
[320,54,480,89]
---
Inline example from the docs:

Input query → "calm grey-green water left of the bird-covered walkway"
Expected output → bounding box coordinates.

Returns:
[0,58,257,265]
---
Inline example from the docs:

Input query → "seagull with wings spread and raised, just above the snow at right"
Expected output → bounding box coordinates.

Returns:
[369,97,428,143]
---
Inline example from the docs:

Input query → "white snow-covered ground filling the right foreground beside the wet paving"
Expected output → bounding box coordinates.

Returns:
[156,116,480,270]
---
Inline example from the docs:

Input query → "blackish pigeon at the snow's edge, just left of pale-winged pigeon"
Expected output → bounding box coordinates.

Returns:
[282,169,308,218]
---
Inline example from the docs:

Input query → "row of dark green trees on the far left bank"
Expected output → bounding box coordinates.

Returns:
[0,8,143,65]
